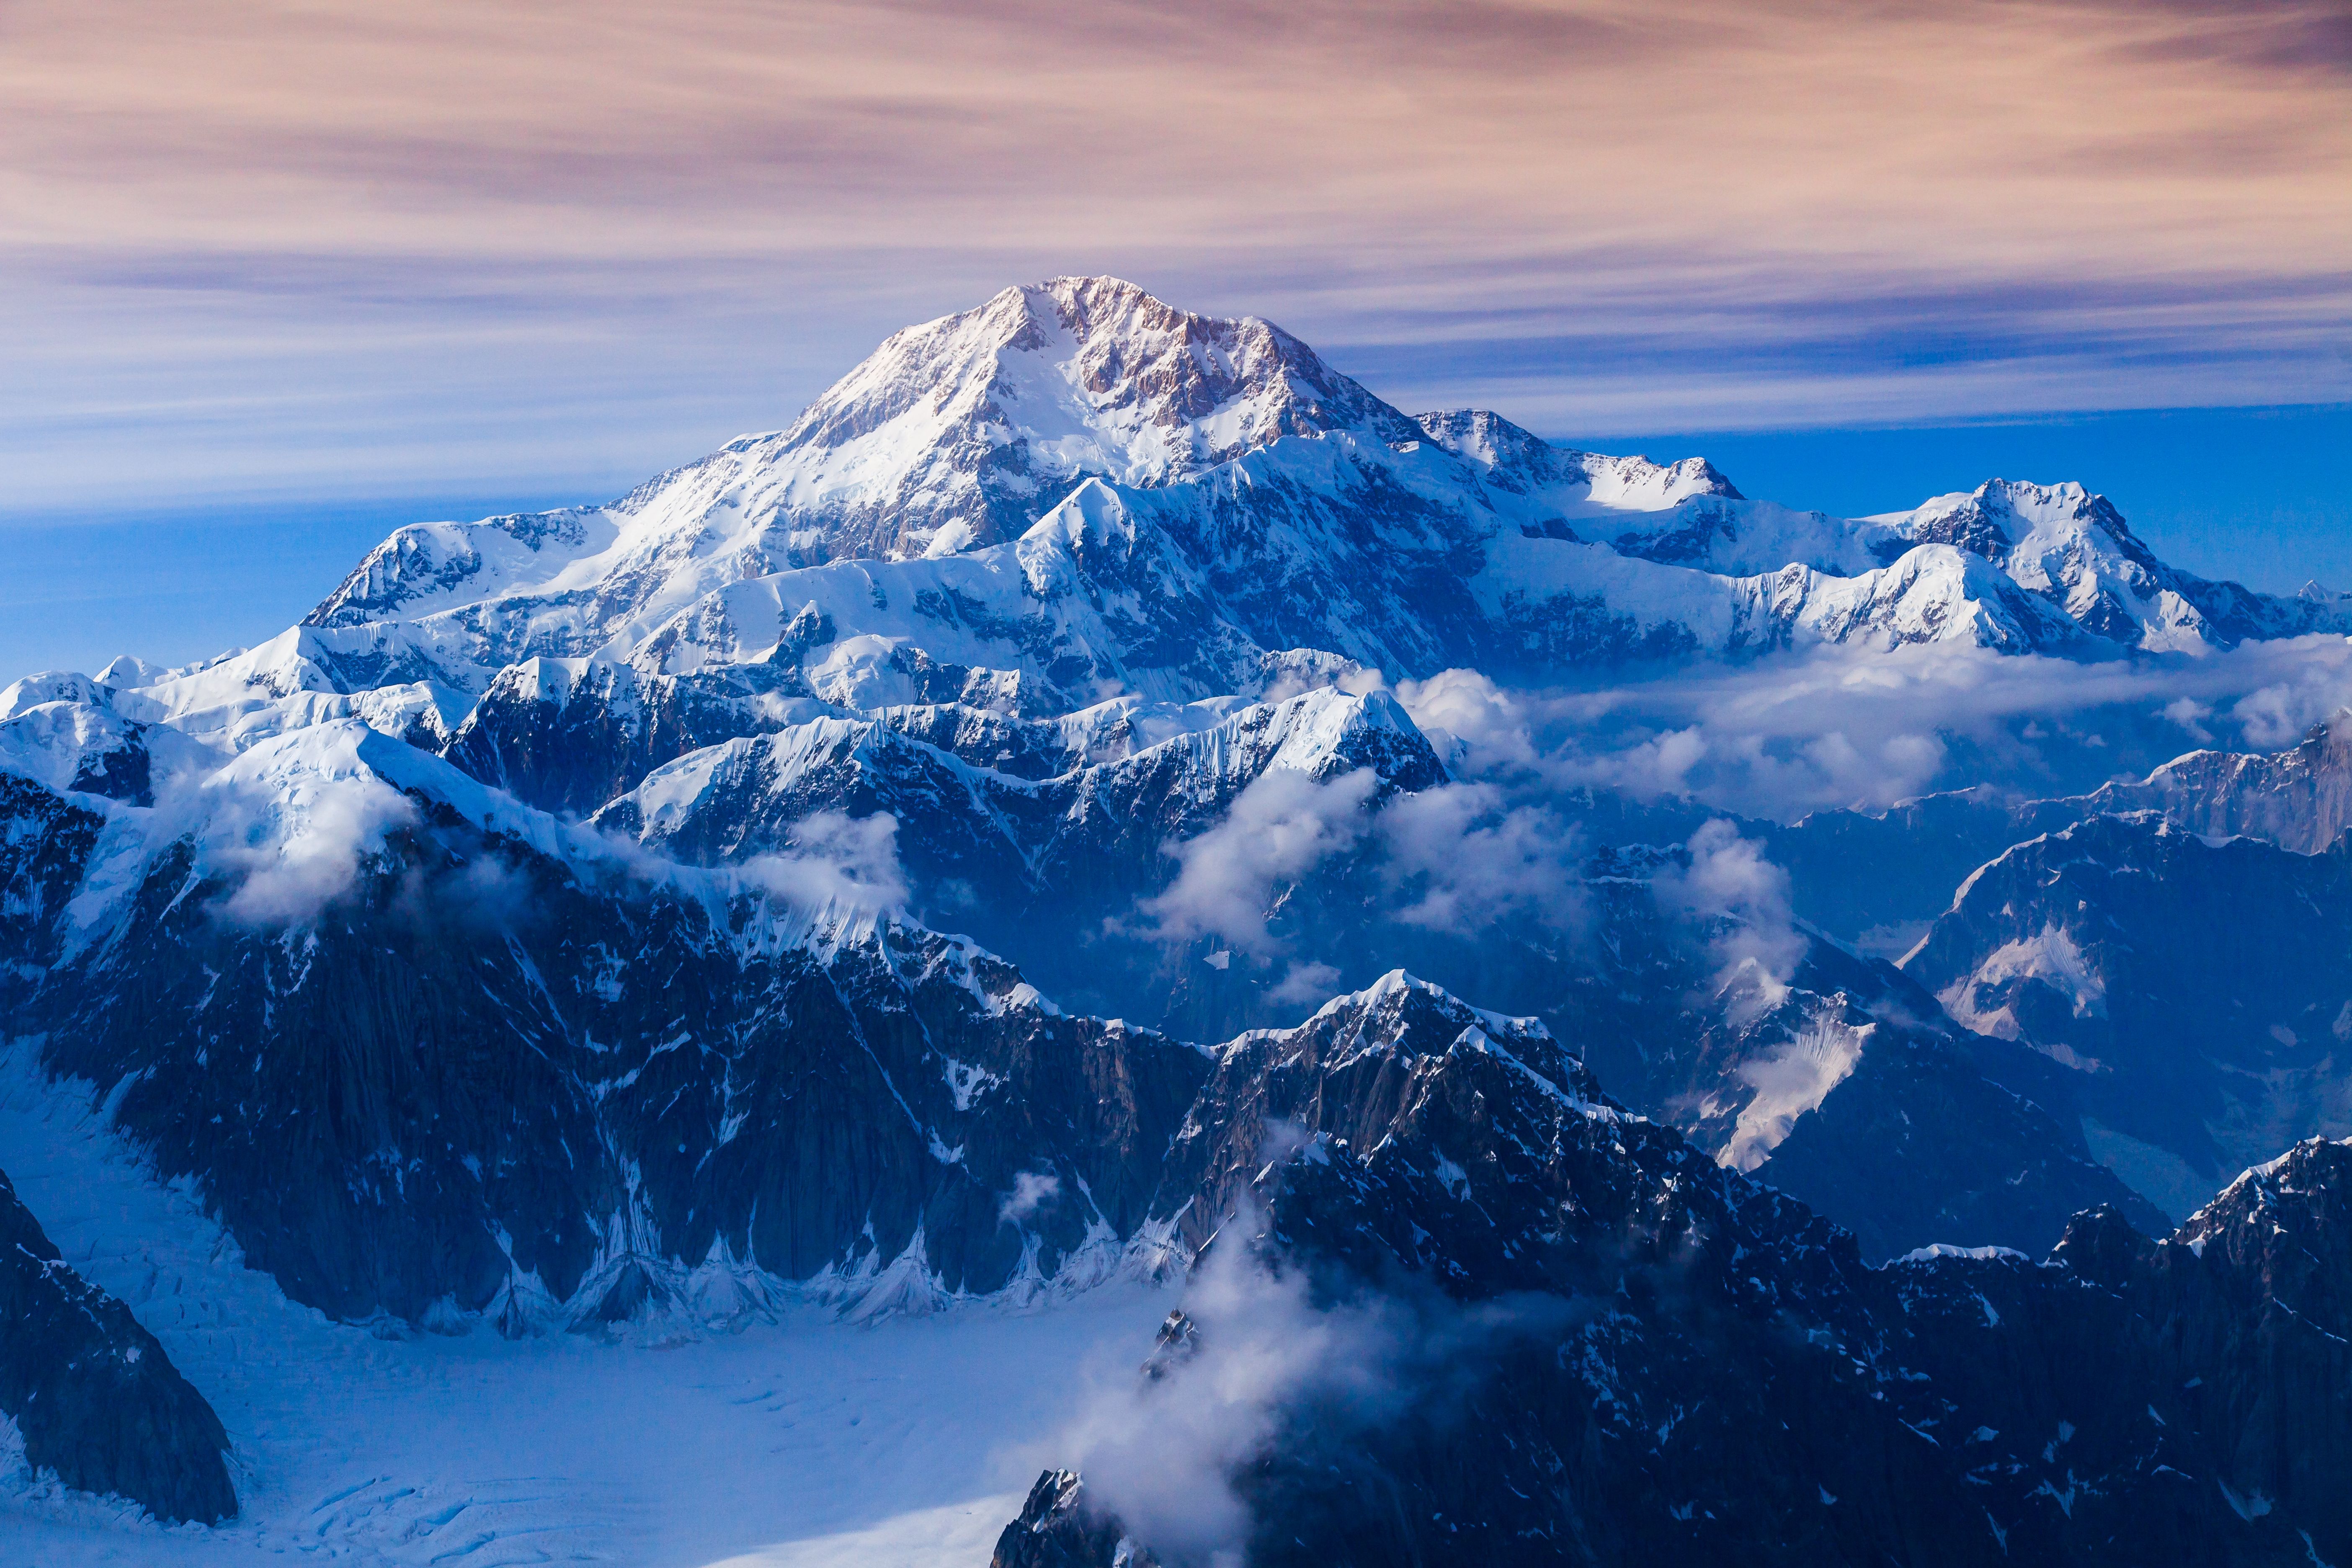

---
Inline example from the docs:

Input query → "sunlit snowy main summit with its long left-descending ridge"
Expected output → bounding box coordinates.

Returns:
[308,277,1421,653]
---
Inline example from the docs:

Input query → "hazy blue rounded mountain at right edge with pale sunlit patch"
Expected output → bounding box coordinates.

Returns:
[1903,816,2352,1213]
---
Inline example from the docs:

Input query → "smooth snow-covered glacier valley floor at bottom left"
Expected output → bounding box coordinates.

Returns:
[0,1053,1173,1568]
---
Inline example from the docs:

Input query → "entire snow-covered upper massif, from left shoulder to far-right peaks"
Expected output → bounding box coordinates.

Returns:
[118,277,2352,766]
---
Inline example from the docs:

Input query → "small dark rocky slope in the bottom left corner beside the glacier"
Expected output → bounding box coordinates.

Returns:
[0,1173,237,1523]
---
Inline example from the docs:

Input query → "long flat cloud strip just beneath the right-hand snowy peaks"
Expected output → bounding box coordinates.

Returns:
[1397,637,2352,820]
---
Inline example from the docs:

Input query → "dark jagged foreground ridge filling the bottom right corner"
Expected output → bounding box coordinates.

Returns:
[997,983,2352,1565]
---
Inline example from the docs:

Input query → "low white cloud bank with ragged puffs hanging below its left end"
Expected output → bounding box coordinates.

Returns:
[1131,637,2352,1011]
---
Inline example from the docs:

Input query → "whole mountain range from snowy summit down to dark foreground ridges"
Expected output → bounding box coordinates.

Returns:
[0,277,2352,1565]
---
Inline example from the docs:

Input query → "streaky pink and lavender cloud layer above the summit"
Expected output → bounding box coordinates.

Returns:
[0,0,2352,496]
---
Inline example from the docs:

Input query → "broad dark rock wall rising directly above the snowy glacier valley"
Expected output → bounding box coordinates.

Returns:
[26,761,1207,1323]
